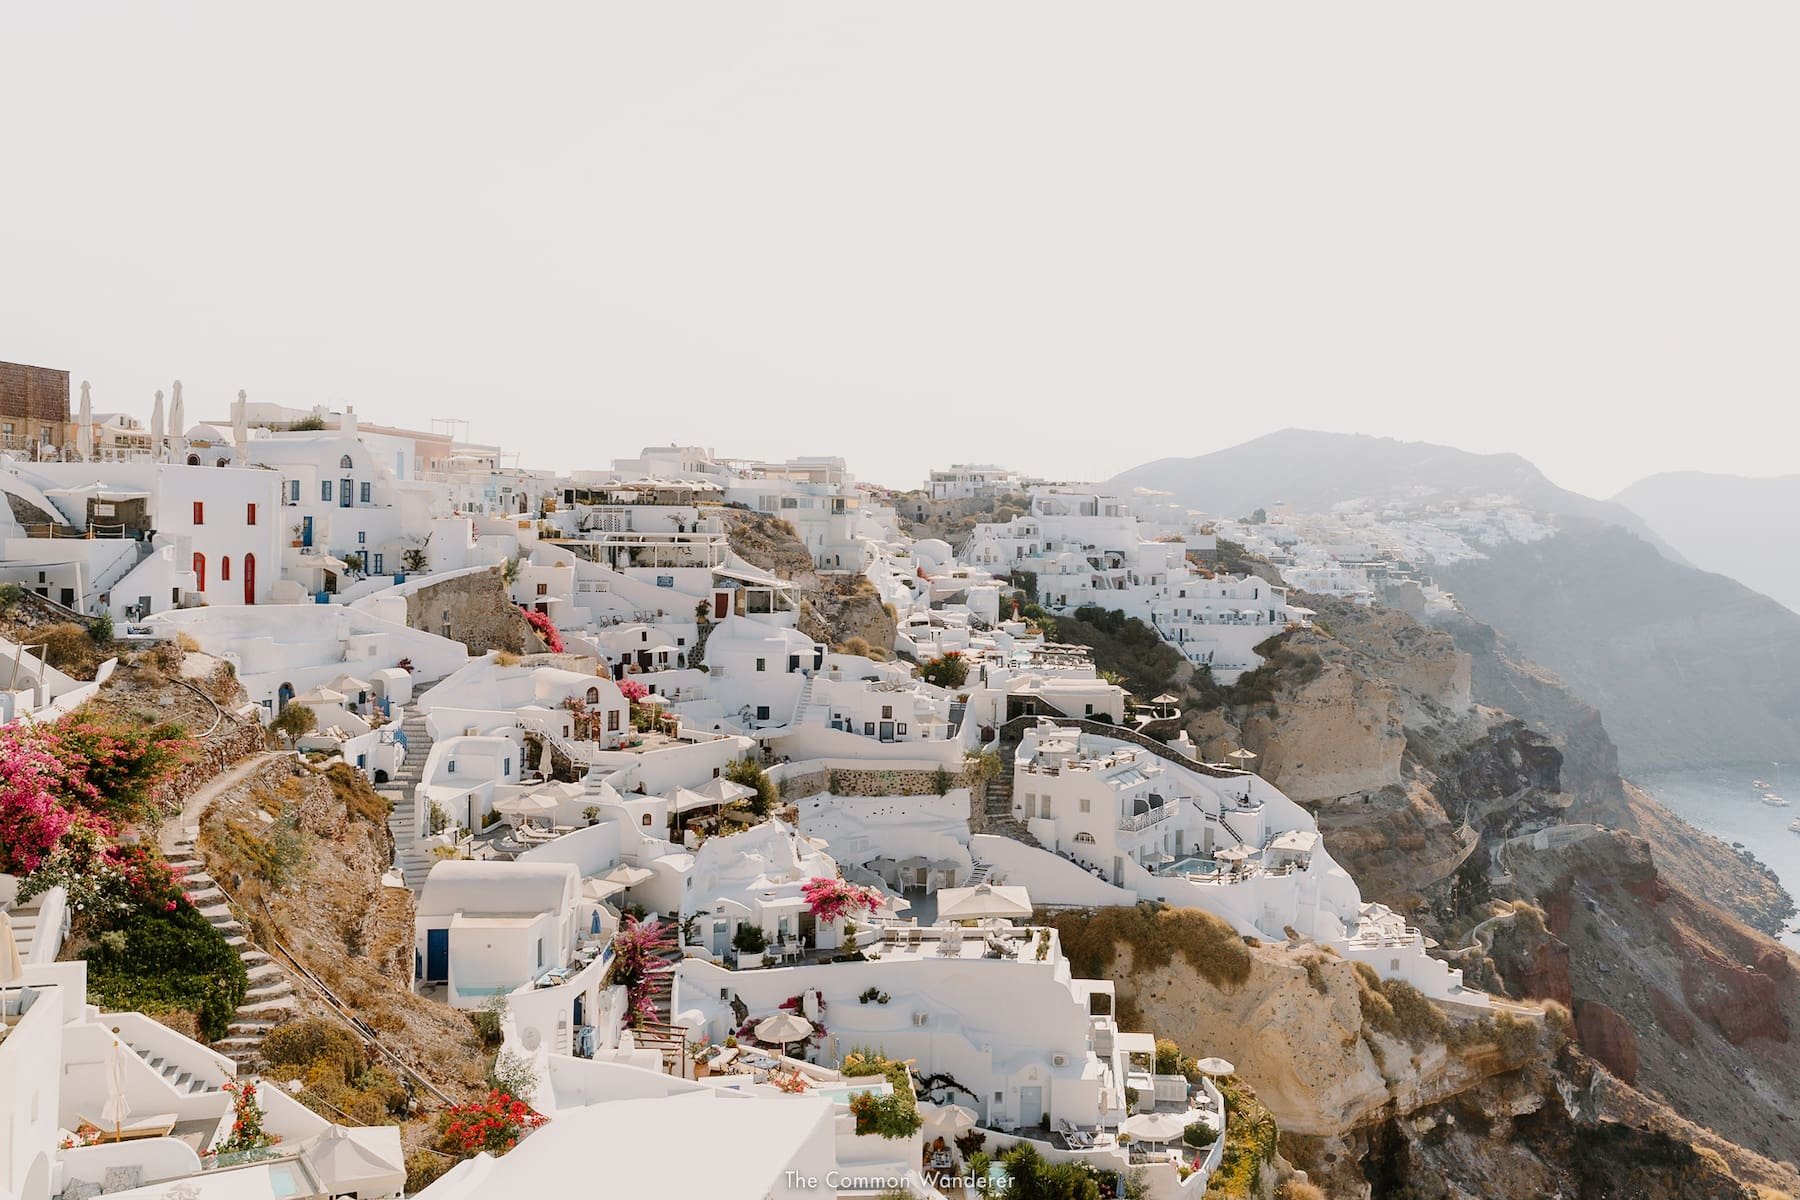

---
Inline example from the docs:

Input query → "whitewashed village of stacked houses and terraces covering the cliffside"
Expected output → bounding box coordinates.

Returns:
[0,365,1490,1200]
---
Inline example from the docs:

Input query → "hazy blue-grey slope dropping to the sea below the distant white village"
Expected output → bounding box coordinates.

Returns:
[1435,524,1800,775]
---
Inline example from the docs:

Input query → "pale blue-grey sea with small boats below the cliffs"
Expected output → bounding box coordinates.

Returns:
[1631,763,1800,950]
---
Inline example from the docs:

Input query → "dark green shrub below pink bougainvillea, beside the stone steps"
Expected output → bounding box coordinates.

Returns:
[83,905,248,1040]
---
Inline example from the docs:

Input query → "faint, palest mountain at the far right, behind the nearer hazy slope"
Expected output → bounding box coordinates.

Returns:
[1613,471,1800,612]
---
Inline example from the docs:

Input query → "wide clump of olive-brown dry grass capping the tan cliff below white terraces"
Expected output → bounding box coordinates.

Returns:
[1037,905,1251,990]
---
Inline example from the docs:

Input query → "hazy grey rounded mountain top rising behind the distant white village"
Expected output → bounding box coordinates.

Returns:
[1112,430,1654,540]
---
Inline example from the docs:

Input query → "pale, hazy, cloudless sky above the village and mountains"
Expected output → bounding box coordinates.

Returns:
[0,0,1800,495]
